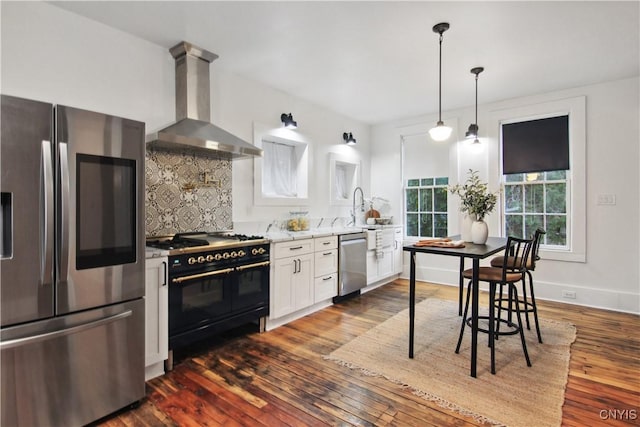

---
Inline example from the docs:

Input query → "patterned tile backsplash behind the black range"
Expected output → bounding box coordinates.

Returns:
[145,149,233,236]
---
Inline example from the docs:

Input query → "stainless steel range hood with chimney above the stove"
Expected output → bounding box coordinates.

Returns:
[147,42,262,159]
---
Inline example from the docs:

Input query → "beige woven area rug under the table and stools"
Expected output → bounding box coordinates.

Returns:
[324,298,576,427]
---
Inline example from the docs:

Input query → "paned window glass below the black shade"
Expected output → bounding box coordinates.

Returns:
[504,170,571,249]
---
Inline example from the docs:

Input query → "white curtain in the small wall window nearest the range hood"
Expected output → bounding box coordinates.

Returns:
[262,141,298,197]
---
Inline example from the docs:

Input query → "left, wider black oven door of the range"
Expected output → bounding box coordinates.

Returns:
[169,267,234,339]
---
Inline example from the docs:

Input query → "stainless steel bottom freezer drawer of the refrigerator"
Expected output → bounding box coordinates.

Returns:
[0,298,145,426]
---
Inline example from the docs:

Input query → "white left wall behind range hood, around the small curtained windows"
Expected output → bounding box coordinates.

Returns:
[0,2,370,234]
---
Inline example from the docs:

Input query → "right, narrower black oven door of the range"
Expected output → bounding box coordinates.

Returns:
[231,261,269,316]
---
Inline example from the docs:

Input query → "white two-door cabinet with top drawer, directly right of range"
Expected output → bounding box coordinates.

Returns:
[270,239,314,319]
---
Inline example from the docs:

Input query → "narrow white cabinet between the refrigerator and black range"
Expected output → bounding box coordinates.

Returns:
[144,257,169,380]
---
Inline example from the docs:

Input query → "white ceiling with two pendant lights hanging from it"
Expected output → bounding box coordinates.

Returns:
[53,1,640,124]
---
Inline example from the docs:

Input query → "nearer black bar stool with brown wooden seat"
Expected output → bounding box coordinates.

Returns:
[456,237,533,374]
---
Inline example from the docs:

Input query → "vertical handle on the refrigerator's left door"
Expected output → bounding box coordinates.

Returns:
[40,140,55,285]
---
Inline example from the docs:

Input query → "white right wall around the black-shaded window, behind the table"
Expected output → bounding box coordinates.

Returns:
[371,77,640,313]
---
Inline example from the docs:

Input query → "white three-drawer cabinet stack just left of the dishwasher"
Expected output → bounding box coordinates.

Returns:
[313,236,338,303]
